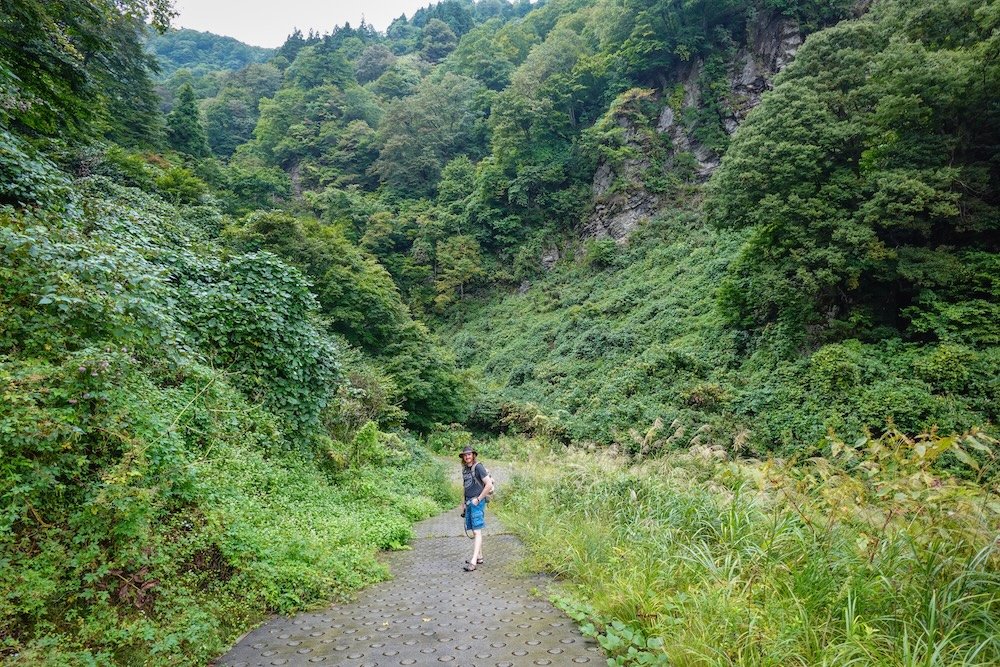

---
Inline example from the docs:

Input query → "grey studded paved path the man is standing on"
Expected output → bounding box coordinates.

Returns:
[218,462,605,667]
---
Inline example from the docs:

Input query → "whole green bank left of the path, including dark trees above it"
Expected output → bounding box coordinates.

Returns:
[0,3,461,665]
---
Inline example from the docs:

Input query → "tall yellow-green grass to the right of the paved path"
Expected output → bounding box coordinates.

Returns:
[503,434,1000,666]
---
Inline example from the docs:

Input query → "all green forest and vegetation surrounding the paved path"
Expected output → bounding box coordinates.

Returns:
[0,0,1000,665]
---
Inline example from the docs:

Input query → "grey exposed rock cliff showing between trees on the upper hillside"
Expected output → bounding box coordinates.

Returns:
[582,14,802,243]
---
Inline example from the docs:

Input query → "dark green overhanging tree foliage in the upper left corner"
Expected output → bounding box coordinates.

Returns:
[0,0,171,143]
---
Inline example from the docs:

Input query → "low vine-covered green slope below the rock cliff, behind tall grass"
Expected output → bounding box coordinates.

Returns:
[447,206,1000,454]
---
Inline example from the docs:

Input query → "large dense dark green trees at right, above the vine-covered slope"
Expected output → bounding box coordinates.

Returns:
[707,0,1000,344]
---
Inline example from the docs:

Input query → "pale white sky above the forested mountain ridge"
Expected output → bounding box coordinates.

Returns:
[172,0,433,47]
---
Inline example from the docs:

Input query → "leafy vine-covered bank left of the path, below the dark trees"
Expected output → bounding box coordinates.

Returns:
[0,152,450,665]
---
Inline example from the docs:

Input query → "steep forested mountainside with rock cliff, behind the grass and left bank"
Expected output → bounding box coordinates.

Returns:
[143,0,1000,452]
